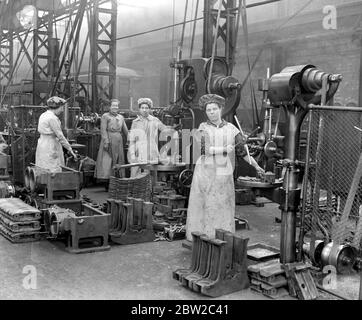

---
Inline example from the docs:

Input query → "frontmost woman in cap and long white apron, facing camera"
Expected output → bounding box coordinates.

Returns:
[186,94,264,241]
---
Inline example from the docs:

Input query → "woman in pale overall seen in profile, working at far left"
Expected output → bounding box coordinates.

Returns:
[35,97,76,172]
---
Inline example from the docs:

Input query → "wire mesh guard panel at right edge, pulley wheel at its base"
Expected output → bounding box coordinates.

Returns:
[299,107,362,273]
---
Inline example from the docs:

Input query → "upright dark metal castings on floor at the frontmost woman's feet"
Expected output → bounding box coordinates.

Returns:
[173,229,249,297]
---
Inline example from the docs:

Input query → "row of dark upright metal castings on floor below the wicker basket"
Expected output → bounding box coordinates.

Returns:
[107,197,155,244]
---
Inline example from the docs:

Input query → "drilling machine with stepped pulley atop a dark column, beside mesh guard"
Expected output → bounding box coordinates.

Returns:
[268,65,342,263]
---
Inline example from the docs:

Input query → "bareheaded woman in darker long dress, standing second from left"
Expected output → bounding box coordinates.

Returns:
[95,99,128,190]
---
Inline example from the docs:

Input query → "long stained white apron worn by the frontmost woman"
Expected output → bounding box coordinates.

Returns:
[186,122,239,241]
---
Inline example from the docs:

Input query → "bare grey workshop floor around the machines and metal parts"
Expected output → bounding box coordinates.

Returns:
[0,188,359,300]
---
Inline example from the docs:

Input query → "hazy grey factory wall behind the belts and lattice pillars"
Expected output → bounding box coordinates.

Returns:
[117,0,362,130]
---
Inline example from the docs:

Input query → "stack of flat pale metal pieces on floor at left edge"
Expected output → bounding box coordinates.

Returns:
[0,198,41,243]
